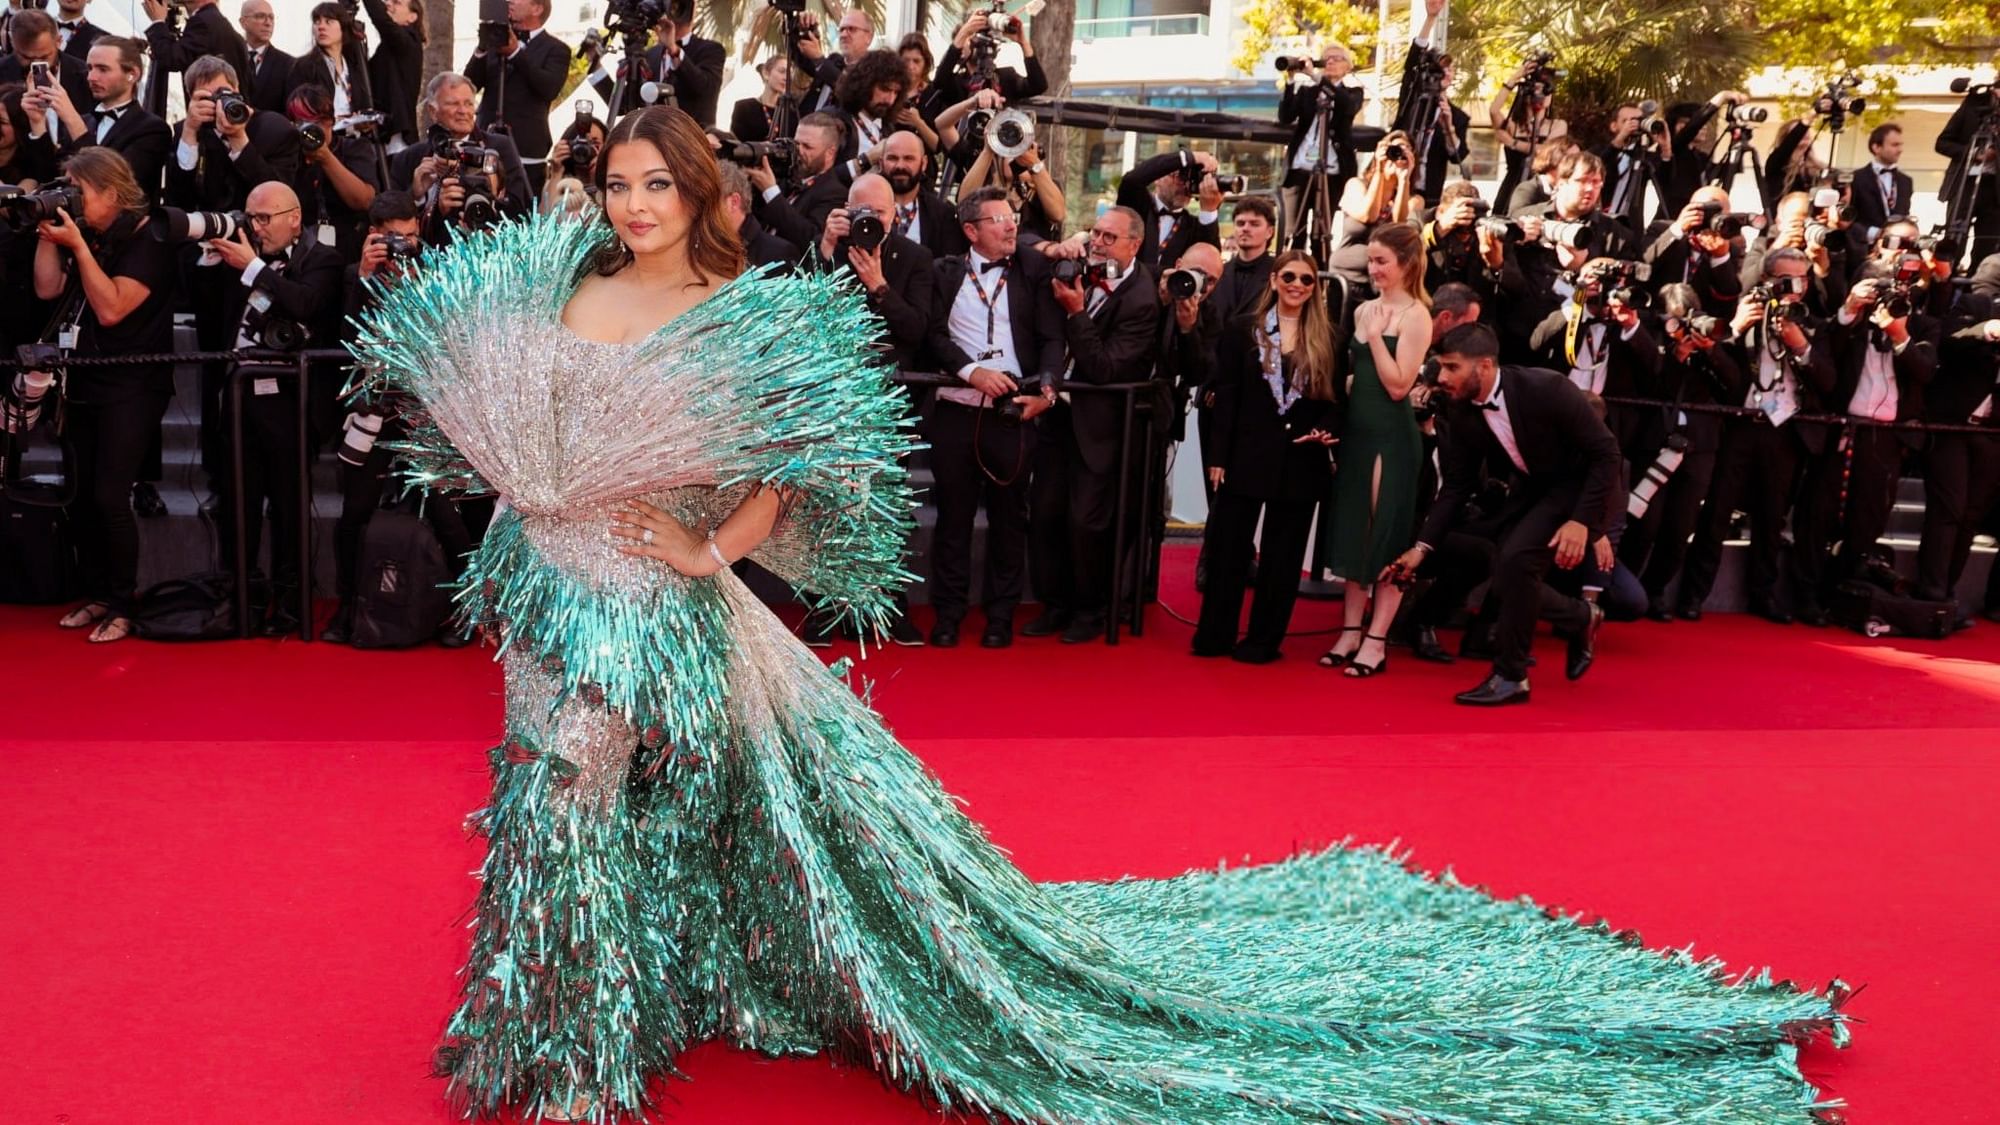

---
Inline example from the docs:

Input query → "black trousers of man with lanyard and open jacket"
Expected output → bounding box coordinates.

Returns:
[924,398,1042,623]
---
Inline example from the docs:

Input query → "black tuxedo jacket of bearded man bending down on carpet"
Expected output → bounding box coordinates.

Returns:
[1416,364,1624,546]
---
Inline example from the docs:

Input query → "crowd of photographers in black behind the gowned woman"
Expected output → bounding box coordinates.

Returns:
[0,0,2000,692]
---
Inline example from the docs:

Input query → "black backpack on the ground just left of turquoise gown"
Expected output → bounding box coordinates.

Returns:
[348,506,452,649]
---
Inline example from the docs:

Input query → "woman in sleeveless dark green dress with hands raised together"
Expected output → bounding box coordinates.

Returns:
[1320,222,1430,677]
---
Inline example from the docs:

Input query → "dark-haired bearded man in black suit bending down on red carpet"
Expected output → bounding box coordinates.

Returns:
[1388,324,1624,707]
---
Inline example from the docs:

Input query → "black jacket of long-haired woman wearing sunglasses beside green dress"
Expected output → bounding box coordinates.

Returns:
[1202,316,1340,500]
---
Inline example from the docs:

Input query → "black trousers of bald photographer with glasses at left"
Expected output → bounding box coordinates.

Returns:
[216,370,306,588]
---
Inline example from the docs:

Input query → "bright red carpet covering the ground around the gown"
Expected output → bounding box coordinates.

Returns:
[0,550,2000,1125]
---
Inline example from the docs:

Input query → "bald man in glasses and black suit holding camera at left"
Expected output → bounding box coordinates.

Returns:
[204,180,342,637]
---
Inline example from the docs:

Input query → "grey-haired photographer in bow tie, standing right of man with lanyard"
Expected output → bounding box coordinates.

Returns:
[1022,201,1172,645]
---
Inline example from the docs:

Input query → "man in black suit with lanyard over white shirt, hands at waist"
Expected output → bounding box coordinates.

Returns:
[924,188,1064,649]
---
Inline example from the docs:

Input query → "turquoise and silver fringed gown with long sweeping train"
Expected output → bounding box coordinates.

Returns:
[356,212,1846,1125]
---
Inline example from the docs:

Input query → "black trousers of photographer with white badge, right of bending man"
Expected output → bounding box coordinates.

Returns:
[1678,416,1806,609]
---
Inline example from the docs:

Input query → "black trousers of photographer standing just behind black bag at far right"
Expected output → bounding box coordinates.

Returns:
[1792,426,1904,605]
